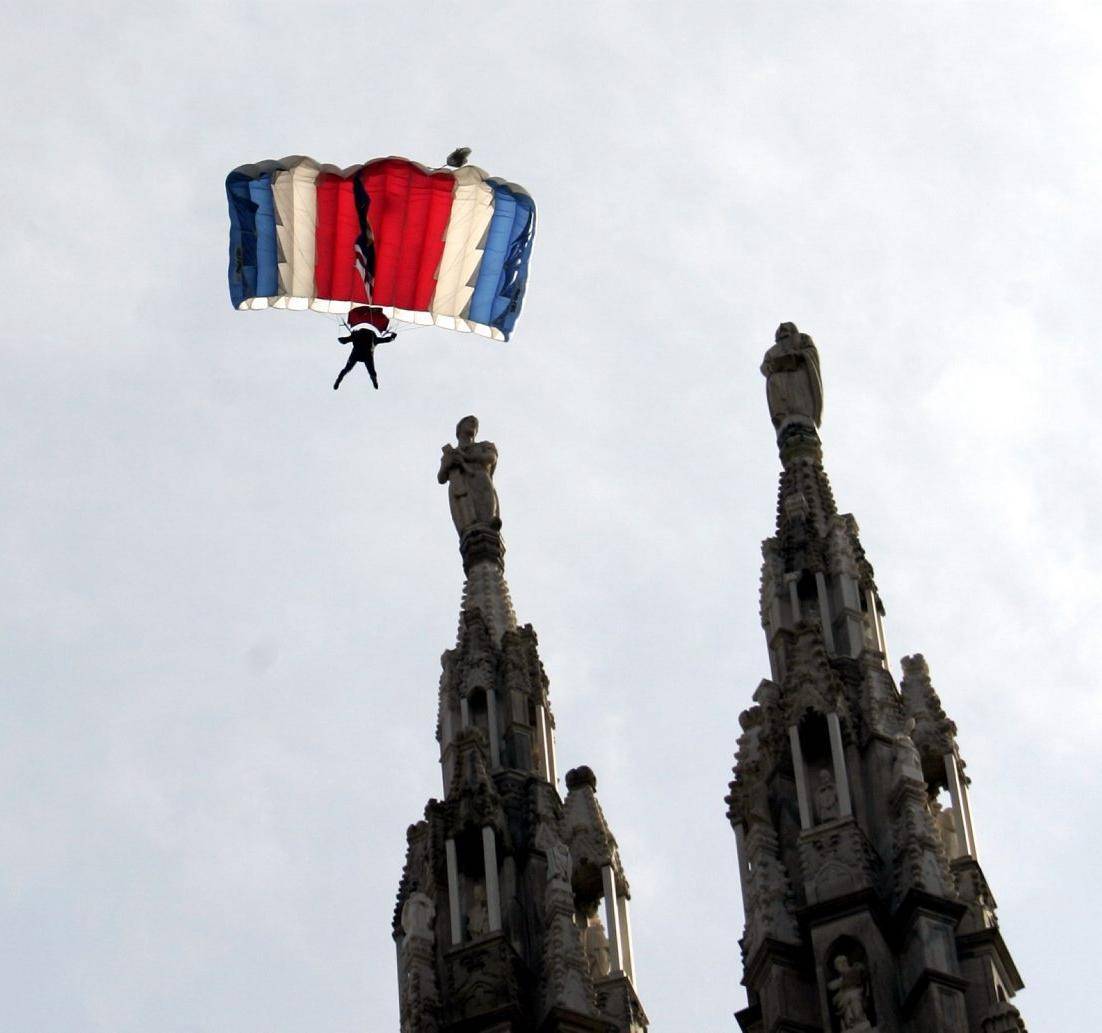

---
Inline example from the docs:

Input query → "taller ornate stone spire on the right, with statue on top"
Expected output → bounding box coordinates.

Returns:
[727,323,1025,1033]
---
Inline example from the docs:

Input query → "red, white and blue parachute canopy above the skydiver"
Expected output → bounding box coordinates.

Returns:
[226,157,536,341]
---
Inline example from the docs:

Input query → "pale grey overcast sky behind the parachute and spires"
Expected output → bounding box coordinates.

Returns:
[0,0,1102,1033]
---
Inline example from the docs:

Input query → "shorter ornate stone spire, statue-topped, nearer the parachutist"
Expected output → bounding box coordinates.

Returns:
[393,417,647,1033]
